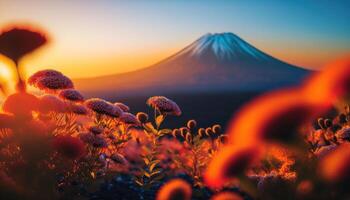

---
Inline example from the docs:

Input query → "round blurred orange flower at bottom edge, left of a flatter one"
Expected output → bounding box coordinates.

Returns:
[156,179,192,200]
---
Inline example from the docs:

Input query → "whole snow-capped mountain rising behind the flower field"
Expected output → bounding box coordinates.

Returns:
[75,33,310,95]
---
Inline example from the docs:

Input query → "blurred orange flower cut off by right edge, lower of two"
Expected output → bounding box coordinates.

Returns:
[318,143,350,182]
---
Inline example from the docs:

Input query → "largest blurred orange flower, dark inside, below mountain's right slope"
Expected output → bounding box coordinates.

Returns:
[228,89,322,146]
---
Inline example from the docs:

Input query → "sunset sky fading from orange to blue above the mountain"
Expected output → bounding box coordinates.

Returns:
[0,0,350,78]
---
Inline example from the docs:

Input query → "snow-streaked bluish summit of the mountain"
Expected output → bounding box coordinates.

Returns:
[184,32,269,60]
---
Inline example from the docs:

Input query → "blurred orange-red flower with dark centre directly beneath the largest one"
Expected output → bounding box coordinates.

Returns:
[204,145,260,188]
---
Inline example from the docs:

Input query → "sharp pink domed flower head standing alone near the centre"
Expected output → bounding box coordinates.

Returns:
[147,96,181,116]
